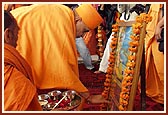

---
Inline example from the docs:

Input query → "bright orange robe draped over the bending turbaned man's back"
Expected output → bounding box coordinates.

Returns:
[11,4,88,92]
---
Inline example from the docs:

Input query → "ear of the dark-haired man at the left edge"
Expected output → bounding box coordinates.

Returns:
[4,28,12,43]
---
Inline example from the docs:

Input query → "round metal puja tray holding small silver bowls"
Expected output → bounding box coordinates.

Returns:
[38,90,81,111]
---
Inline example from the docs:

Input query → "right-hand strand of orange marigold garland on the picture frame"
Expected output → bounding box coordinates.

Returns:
[118,13,152,111]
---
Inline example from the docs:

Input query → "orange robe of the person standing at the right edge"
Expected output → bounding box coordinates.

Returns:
[145,4,164,104]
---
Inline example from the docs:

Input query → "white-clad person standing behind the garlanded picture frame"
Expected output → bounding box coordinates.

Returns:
[94,4,144,73]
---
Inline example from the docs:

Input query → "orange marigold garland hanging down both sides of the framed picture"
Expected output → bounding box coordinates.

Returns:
[100,13,152,111]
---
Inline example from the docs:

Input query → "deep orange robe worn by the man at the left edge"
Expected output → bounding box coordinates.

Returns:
[4,44,42,111]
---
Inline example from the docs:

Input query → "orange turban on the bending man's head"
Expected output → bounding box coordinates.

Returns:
[76,4,103,29]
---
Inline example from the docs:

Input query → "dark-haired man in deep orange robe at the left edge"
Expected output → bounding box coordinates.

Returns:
[4,11,42,111]
